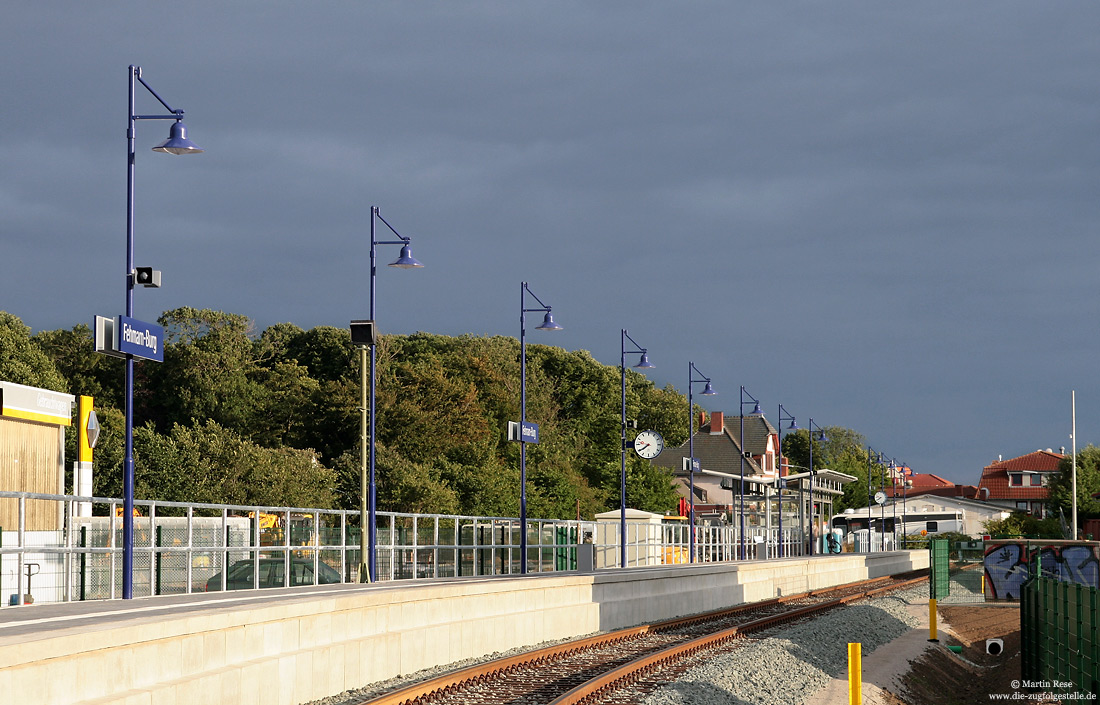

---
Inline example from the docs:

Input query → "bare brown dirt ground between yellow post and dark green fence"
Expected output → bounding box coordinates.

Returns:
[888,605,1041,705]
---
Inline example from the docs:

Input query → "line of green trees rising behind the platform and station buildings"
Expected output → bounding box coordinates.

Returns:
[8,308,1100,518]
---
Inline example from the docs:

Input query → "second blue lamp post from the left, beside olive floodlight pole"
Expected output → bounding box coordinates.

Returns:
[353,206,424,583]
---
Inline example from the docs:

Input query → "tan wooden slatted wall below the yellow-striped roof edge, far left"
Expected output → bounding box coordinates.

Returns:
[0,417,65,531]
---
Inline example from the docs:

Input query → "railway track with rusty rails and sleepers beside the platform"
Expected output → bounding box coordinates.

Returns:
[361,571,927,705]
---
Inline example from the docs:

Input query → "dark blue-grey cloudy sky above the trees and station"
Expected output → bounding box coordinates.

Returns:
[0,0,1100,483]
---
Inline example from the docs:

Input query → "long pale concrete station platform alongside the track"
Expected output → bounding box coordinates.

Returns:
[0,551,928,705]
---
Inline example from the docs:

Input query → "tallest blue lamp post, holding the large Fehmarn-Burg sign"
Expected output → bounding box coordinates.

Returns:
[122,66,202,599]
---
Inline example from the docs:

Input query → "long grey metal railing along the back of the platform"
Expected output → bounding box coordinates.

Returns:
[0,492,818,604]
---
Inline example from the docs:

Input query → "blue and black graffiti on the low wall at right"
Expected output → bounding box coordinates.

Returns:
[985,542,1100,599]
